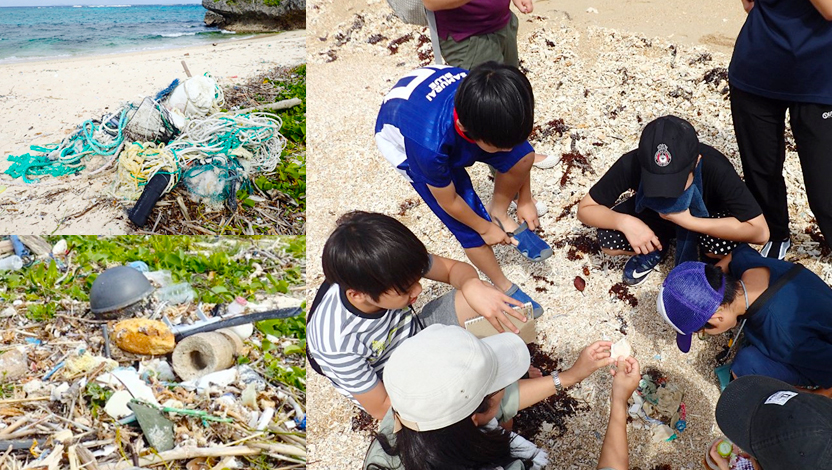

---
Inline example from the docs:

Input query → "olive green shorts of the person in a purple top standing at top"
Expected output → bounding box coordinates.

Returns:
[439,12,520,70]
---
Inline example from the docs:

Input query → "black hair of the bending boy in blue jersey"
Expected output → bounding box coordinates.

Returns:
[454,61,534,149]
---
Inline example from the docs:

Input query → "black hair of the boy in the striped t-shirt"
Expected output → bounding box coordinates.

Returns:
[322,211,430,301]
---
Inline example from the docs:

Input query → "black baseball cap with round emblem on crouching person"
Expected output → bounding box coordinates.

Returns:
[638,116,699,198]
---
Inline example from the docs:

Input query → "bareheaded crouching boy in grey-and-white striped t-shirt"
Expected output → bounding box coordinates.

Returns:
[307,212,536,419]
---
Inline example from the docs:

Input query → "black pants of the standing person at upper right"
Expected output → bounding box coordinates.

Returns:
[731,87,832,243]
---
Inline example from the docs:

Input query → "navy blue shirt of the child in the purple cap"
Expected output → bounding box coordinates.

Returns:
[729,244,832,388]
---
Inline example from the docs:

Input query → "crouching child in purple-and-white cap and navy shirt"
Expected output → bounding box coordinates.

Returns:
[657,244,832,395]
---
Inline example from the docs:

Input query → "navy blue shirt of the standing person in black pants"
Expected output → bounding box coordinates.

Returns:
[728,0,832,104]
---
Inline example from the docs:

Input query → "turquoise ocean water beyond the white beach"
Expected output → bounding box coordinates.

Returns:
[0,4,247,63]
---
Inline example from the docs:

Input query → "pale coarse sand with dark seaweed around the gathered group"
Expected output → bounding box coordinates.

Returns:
[307,0,832,470]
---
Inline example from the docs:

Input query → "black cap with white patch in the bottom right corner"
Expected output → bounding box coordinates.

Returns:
[716,375,832,470]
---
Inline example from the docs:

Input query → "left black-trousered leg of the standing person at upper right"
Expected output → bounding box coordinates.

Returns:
[731,87,789,241]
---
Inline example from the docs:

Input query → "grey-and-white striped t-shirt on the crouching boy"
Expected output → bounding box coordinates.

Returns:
[306,282,417,403]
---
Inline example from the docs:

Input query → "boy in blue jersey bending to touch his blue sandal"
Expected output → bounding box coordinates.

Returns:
[375,62,552,316]
